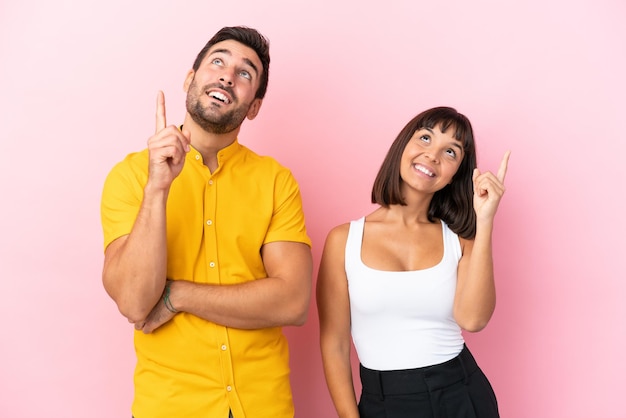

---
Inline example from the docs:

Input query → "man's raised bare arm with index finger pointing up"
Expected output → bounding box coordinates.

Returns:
[102,92,190,323]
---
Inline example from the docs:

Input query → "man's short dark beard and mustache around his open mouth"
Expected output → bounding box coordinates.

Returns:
[186,80,250,134]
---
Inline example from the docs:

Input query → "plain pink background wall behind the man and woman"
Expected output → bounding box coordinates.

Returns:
[0,0,626,418]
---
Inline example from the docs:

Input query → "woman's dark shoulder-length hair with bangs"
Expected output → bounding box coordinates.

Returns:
[372,107,476,239]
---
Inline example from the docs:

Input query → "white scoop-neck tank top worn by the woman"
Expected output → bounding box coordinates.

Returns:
[346,217,464,370]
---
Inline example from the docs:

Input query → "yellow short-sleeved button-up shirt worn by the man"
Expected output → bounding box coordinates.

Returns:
[101,141,311,418]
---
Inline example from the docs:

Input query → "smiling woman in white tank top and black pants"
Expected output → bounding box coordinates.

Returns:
[317,107,509,418]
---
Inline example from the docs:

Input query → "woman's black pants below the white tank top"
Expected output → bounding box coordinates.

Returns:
[359,347,500,418]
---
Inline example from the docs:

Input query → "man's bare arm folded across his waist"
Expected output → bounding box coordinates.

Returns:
[143,241,313,332]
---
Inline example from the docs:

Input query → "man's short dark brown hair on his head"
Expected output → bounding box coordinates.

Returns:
[193,26,270,99]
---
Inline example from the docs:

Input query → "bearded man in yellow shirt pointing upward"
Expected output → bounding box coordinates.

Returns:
[101,27,312,418]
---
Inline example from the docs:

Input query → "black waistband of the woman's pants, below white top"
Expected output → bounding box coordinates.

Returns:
[360,345,478,396]
